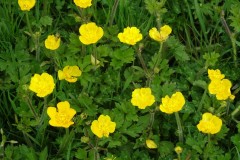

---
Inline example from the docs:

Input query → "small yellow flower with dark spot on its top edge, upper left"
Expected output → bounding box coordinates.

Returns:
[45,35,61,50]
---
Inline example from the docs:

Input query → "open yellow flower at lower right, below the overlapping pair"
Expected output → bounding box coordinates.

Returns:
[197,113,222,134]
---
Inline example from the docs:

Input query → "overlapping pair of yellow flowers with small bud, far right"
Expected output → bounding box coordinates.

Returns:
[208,69,234,100]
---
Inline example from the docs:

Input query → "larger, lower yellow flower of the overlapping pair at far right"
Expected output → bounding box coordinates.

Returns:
[208,79,235,100]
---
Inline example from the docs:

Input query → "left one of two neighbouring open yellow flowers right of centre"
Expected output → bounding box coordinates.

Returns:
[131,88,155,109]
